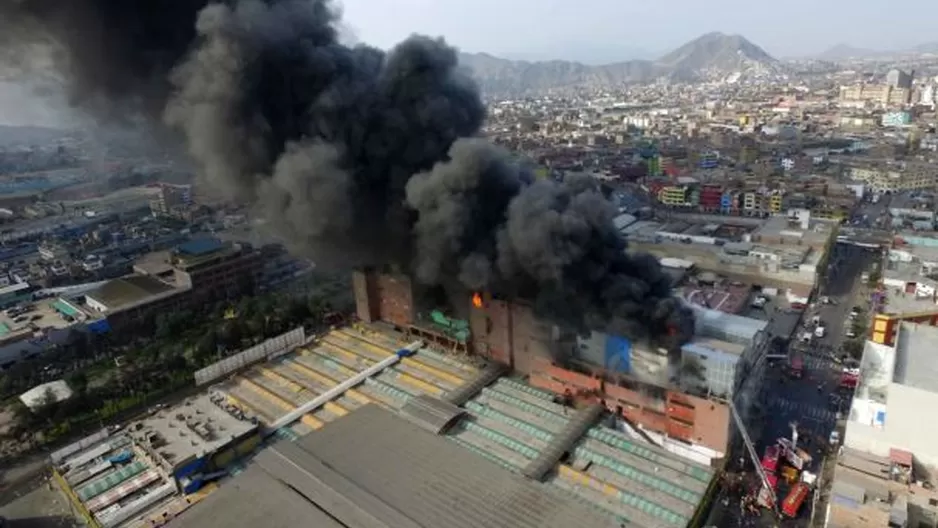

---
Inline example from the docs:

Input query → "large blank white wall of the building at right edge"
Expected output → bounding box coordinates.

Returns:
[844,384,938,465]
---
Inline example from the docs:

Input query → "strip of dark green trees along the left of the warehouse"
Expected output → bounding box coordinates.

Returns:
[0,272,349,454]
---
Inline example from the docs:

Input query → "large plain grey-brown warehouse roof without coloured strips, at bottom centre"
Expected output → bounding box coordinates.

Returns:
[172,405,618,528]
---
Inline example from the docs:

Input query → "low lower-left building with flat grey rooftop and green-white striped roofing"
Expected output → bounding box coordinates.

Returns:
[50,394,260,528]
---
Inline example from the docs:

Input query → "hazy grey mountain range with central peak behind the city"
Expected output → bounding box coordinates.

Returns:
[460,33,783,96]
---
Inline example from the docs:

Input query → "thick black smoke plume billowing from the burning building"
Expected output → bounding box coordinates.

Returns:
[0,0,693,343]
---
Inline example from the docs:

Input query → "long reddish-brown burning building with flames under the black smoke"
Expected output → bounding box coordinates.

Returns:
[354,271,744,460]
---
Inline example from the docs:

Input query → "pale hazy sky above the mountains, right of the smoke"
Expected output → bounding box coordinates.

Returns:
[342,0,938,62]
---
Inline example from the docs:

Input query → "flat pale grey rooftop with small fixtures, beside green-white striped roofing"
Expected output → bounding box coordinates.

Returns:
[128,394,257,467]
